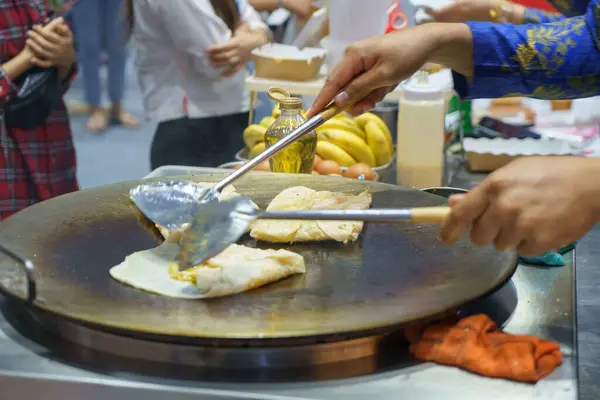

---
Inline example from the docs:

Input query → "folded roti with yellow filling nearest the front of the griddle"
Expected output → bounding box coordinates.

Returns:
[110,241,306,299]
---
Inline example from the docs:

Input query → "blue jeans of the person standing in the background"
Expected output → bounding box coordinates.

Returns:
[73,0,127,107]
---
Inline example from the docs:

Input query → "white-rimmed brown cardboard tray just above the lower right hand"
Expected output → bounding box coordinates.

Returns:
[463,138,574,172]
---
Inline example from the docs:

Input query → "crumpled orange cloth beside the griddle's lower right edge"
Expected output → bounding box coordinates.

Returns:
[404,314,563,382]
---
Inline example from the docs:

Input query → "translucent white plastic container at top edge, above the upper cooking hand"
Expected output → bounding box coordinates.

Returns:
[328,0,394,42]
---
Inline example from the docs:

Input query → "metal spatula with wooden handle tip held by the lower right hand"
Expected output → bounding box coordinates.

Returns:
[178,197,450,271]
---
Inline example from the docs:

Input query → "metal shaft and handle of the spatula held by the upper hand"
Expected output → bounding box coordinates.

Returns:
[213,100,358,192]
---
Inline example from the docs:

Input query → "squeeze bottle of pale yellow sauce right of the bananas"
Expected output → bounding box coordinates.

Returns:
[396,71,445,189]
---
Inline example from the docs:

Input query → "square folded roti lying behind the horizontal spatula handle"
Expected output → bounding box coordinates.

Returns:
[250,186,372,243]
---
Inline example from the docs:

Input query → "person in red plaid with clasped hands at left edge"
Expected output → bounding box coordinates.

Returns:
[0,7,78,219]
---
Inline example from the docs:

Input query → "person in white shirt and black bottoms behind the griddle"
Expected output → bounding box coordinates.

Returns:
[127,0,269,169]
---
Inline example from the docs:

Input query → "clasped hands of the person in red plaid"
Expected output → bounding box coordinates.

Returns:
[26,18,75,68]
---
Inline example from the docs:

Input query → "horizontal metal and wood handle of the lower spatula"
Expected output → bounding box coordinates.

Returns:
[258,207,450,225]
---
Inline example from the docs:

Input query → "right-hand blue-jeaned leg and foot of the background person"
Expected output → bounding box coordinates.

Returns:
[103,0,138,127]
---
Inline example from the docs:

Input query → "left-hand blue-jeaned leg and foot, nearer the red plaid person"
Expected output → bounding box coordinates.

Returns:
[73,0,106,132]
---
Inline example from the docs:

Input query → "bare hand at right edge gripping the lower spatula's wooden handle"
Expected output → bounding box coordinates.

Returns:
[440,157,600,257]
